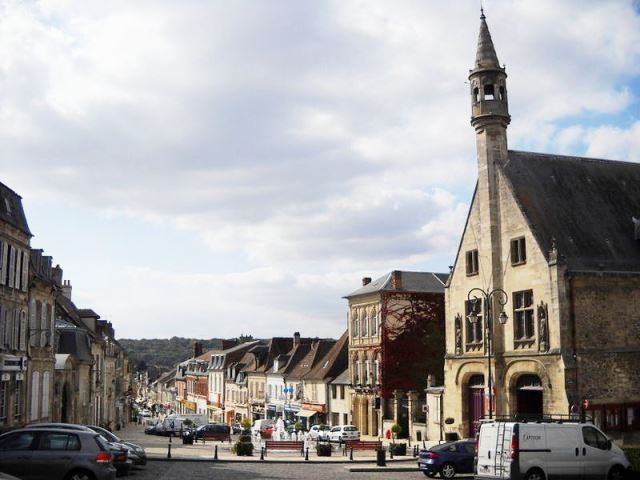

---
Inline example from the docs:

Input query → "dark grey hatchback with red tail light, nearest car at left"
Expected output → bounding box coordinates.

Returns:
[0,427,116,480]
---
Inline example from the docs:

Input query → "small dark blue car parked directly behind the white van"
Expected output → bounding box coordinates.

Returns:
[418,440,475,478]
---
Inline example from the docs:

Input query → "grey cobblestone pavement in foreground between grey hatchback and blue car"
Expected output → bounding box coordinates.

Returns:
[124,461,425,480]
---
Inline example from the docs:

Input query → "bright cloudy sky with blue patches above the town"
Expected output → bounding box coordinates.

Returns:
[0,0,640,338]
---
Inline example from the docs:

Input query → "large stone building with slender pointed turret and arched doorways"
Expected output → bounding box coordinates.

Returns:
[444,10,640,437]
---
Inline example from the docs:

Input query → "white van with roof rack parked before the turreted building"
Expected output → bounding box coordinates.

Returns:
[475,420,631,480]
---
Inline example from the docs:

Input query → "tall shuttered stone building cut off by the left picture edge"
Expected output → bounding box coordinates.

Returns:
[0,183,31,429]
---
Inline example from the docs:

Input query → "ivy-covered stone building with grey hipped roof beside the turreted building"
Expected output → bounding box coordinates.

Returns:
[345,270,448,438]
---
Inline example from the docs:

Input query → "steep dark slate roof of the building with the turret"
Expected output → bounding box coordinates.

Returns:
[504,151,640,272]
